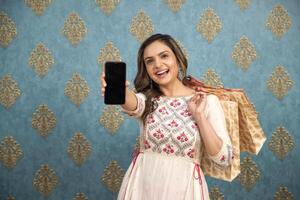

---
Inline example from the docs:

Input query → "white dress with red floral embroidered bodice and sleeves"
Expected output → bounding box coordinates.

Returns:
[118,93,232,200]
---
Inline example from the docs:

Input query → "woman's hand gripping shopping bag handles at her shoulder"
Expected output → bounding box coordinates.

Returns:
[188,92,207,118]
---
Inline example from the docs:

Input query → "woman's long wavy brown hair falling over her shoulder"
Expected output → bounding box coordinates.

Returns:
[134,34,188,123]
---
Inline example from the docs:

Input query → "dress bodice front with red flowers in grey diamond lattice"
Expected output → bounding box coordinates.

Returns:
[144,97,199,159]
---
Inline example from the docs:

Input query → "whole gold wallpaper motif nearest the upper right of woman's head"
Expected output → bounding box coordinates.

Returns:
[196,8,222,43]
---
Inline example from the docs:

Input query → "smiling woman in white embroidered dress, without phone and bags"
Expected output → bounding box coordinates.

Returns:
[101,34,232,200]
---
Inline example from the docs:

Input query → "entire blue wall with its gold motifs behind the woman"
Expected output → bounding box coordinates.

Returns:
[0,0,300,200]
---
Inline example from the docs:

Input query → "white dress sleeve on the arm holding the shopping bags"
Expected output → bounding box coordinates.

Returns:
[205,95,233,166]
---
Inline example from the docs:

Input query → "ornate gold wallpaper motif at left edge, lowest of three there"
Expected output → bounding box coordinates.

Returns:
[0,136,23,169]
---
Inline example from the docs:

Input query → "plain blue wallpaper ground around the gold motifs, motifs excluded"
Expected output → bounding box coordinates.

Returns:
[0,0,300,200]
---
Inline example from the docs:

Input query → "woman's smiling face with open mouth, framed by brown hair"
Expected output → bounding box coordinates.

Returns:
[144,41,178,86]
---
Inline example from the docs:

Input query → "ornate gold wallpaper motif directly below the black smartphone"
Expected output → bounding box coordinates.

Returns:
[99,105,124,134]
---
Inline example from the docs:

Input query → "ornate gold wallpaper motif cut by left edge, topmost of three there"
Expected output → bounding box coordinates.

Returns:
[0,11,17,47]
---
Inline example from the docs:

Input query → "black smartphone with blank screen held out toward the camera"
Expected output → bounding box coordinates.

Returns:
[104,62,126,105]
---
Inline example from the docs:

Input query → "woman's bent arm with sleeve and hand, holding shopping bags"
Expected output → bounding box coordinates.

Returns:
[189,94,232,166]
